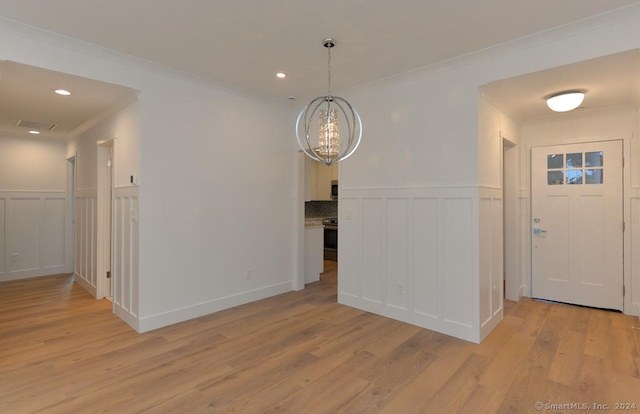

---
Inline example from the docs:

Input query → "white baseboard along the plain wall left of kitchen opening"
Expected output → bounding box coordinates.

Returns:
[139,282,292,333]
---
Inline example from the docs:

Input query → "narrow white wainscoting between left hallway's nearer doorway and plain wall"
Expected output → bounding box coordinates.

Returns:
[112,187,139,330]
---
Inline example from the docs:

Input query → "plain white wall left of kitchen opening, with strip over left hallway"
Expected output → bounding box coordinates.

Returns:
[0,20,297,331]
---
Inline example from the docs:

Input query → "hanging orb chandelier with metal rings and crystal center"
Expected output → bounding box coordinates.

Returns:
[296,39,362,165]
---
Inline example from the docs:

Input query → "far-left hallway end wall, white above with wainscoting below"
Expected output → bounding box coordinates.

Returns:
[0,137,66,281]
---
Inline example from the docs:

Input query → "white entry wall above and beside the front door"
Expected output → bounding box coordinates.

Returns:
[521,107,640,314]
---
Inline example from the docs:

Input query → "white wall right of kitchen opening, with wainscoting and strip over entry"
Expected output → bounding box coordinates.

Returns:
[339,7,640,341]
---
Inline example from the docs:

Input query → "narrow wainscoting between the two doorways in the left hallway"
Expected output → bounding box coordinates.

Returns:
[75,190,98,296]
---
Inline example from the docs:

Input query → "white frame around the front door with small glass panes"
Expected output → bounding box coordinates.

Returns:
[524,134,640,316]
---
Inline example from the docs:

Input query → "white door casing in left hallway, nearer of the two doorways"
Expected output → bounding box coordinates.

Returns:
[96,137,117,299]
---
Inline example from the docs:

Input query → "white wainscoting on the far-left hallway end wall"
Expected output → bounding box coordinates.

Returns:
[0,191,66,281]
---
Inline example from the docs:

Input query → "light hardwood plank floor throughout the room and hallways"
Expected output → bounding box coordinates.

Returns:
[0,263,640,414]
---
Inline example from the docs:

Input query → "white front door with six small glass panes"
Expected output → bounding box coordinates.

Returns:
[531,141,624,310]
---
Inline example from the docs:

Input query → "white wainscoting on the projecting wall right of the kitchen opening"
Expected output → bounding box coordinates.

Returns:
[338,187,502,342]
